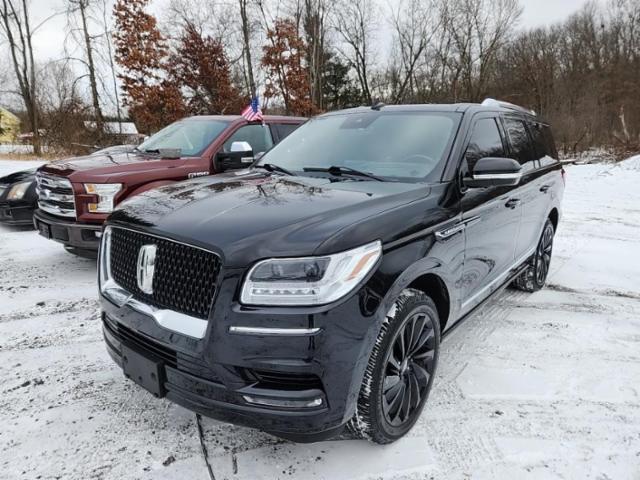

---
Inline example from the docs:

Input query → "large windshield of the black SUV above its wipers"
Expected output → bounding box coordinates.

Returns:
[258,111,460,181]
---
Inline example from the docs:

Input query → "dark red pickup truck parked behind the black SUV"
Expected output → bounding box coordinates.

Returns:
[34,115,306,257]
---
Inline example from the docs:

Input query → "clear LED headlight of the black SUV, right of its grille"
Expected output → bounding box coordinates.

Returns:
[240,241,382,305]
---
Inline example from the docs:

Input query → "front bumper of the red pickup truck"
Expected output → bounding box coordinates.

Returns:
[33,210,102,252]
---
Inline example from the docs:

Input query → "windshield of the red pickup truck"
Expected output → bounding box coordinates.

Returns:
[138,120,229,157]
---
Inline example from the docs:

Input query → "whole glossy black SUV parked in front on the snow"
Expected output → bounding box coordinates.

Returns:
[99,100,564,443]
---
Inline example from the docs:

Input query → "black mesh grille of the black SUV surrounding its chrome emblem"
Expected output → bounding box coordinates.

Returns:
[110,228,220,319]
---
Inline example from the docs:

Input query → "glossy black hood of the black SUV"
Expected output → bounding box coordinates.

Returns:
[109,171,430,266]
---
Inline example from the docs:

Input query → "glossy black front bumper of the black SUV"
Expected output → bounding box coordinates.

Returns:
[101,272,379,442]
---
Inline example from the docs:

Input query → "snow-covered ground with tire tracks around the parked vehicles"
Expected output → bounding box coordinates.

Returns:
[0,157,640,480]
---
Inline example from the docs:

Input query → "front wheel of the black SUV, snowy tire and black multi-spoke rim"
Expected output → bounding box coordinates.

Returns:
[348,289,440,444]
